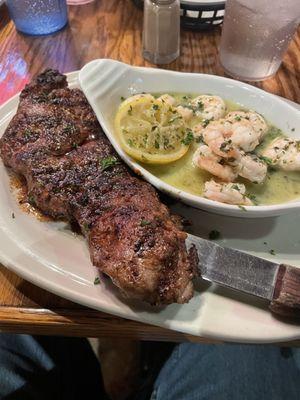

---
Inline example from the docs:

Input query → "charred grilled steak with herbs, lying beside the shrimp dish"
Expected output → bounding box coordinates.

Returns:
[0,70,194,304]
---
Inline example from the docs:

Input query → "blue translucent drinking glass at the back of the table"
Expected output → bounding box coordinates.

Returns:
[6,0,68,35]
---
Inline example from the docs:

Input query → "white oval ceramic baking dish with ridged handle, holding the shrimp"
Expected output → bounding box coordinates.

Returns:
[79,59,300,218]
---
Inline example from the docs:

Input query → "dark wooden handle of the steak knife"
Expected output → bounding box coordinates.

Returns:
[270,264,300,318]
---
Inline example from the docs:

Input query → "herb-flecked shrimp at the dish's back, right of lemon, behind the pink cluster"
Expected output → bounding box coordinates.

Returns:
[191,95,226,120]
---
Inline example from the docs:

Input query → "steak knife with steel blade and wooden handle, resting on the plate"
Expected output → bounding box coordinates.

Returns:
[186,234,300,318]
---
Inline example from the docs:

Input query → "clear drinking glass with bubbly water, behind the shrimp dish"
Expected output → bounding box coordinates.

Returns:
[220,0,300,81]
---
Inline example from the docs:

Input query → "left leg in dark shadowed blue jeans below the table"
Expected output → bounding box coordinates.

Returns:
[0,334,107,400]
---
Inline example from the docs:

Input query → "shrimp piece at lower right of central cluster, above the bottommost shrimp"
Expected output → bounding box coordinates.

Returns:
[235,153,268,183]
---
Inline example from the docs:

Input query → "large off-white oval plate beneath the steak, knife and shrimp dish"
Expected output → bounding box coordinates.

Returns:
[0,72,300,343]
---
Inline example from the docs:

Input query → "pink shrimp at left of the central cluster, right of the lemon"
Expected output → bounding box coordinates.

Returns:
[193,120,239,159]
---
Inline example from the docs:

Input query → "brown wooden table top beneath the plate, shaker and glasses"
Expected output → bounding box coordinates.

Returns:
[0,0,300,342]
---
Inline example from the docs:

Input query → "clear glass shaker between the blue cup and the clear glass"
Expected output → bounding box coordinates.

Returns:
[143,0,180,64]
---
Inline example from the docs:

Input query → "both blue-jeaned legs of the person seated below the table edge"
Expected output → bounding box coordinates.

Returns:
[0,334,300,400]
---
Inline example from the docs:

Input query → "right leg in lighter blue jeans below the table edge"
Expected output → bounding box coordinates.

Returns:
[151,344,300,400]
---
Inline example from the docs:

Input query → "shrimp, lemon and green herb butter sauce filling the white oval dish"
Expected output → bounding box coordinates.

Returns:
[122,88,300,211]
